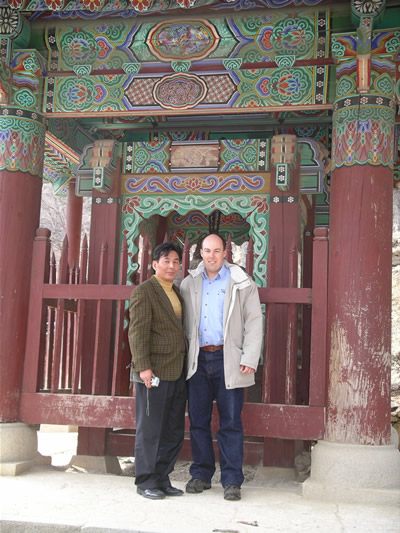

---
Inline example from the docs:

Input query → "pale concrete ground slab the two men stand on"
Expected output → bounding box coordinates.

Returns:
[0,433,400,533]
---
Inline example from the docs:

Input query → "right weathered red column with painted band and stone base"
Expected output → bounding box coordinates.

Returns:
[306,40,400,502]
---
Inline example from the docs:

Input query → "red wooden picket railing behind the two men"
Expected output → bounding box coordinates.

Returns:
[20,228,328,440]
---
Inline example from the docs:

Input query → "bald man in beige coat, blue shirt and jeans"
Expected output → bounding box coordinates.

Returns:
[180,234,262,500]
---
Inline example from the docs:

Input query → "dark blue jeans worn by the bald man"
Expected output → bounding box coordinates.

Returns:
[187,350,244,487]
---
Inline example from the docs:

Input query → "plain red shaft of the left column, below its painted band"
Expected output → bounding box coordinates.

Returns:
[0,168,42,422]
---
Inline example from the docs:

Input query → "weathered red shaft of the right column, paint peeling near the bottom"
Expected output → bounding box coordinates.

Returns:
[326,165,393,445]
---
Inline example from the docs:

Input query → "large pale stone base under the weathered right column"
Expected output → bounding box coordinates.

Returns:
[302,441,400,505]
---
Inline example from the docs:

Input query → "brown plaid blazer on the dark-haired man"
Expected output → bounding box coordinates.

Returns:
[128,276,186,381]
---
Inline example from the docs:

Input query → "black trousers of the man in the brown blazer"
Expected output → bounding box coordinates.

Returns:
[135,375,186,489]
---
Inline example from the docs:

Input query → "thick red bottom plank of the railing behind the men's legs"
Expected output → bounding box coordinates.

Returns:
[19,393,325,440]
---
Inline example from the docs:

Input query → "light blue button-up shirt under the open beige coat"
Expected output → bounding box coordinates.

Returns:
[199,265,231,347]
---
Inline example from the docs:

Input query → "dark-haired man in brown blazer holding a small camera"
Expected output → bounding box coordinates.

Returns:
[129,242,186,500]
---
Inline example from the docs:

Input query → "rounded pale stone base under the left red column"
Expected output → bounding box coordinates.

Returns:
[0,422,51,476]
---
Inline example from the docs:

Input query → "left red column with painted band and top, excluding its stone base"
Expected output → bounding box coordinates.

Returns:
[0,33,45,426]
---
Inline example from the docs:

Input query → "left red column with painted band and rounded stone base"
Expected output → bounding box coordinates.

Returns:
[0,102,45,475]
